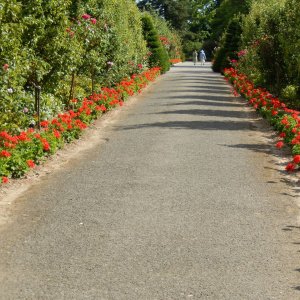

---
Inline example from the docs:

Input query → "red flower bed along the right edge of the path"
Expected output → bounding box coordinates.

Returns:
[224,68,300,172]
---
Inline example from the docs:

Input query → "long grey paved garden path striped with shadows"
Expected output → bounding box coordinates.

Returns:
[0,62,300,300]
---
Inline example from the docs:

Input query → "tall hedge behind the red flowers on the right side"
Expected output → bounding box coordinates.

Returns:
[238,0,300,107]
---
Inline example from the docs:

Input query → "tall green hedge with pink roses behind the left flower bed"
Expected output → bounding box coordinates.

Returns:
[0,0,147,131]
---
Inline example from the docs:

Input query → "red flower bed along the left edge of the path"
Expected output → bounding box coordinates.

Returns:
[0,68,160,183]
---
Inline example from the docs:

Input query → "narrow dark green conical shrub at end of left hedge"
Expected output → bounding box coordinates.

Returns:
[142,12,170,73]
